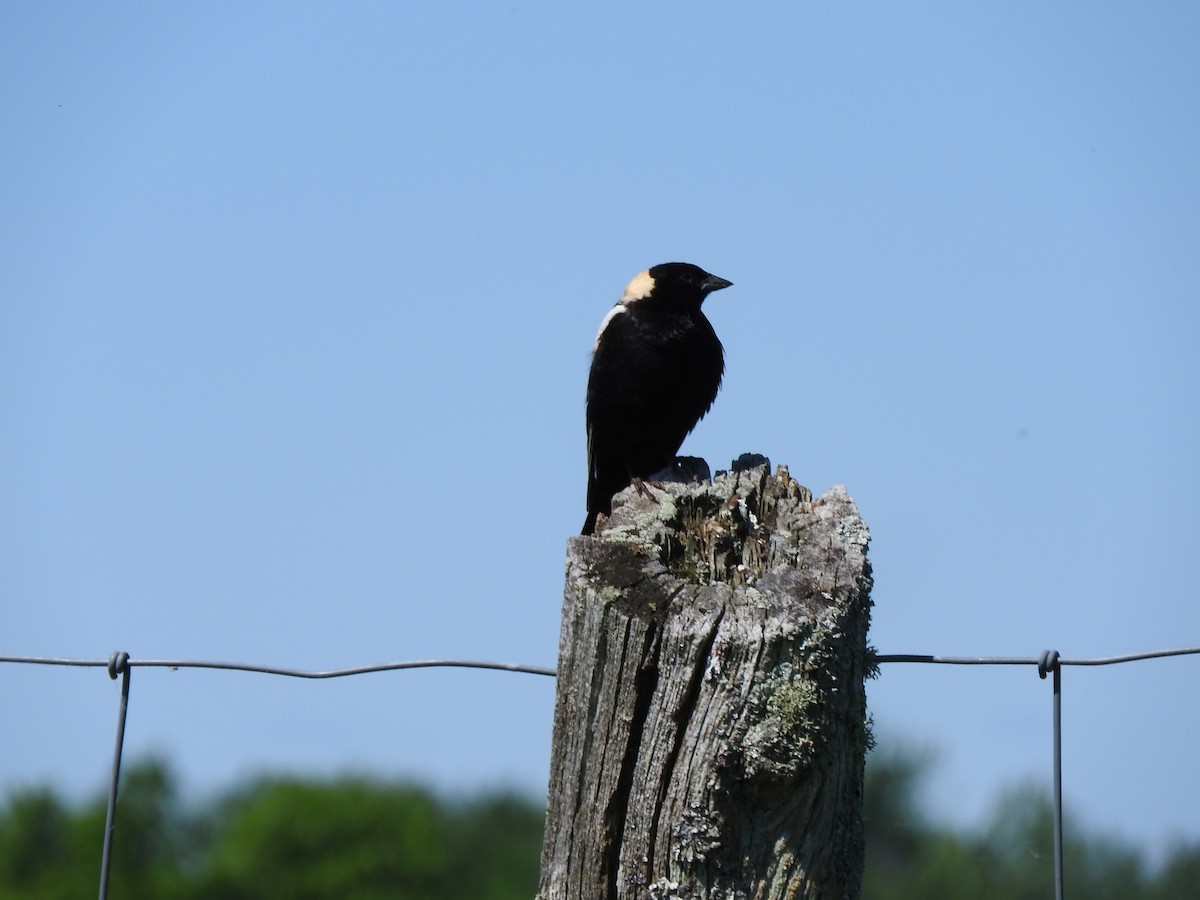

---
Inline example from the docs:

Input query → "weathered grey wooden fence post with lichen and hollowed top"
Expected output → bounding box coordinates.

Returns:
[539,464,871,900]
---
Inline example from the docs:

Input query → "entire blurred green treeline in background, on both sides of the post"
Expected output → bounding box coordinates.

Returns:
[0,752,1200,900]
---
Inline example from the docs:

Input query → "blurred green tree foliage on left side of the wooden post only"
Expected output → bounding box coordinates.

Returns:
[0,760,542,900]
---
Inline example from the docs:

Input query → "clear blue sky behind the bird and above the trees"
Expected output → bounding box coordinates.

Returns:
[0,2,1200,859]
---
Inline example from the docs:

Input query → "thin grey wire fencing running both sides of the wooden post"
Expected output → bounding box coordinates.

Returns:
[0,647,1200,900]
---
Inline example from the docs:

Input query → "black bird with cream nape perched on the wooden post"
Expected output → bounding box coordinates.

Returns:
[583,263,732,534]
